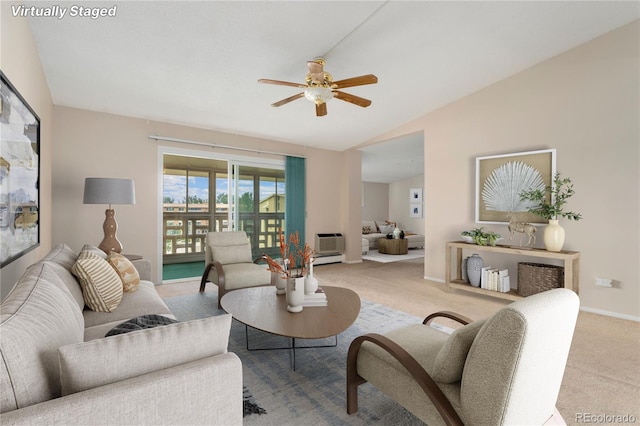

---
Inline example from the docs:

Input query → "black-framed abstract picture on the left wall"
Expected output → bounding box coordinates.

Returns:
[0,71,40,268]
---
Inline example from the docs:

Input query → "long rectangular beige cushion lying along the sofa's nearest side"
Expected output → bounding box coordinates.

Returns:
[58,314,231,395]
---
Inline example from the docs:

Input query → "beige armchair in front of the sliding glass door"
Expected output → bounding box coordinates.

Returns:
[200,231,271,307]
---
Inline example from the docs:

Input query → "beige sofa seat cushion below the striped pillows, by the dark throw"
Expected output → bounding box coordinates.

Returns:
[82,281,172,332]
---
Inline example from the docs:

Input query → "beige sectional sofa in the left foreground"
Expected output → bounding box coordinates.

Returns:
[0,244,243,425]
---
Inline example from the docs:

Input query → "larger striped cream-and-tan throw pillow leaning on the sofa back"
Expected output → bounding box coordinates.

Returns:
[71,250,123,312]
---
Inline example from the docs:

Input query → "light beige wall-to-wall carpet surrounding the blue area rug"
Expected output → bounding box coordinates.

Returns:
[157,260,640,425]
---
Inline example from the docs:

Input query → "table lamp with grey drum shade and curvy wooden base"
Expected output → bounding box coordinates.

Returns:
[83,178,136,254]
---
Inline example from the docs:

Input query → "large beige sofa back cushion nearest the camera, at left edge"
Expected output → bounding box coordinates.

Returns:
[0,262,84,412]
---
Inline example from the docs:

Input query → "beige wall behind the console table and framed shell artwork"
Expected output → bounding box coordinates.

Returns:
[371,21,640,320]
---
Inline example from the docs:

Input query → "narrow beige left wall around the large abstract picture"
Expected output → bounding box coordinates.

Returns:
[0,1,53,298]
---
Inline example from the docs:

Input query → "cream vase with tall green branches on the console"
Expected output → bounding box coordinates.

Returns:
[519,172,582,252]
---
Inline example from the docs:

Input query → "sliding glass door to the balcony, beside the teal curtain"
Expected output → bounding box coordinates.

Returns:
[162,154,286,264]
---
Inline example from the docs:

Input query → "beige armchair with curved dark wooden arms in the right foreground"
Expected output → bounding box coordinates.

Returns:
[347,288,579,426]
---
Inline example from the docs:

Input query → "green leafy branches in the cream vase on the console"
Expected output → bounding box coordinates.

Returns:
[519,172,582,221]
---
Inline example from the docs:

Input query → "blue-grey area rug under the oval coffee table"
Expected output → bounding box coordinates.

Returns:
[165,292,423,426]
